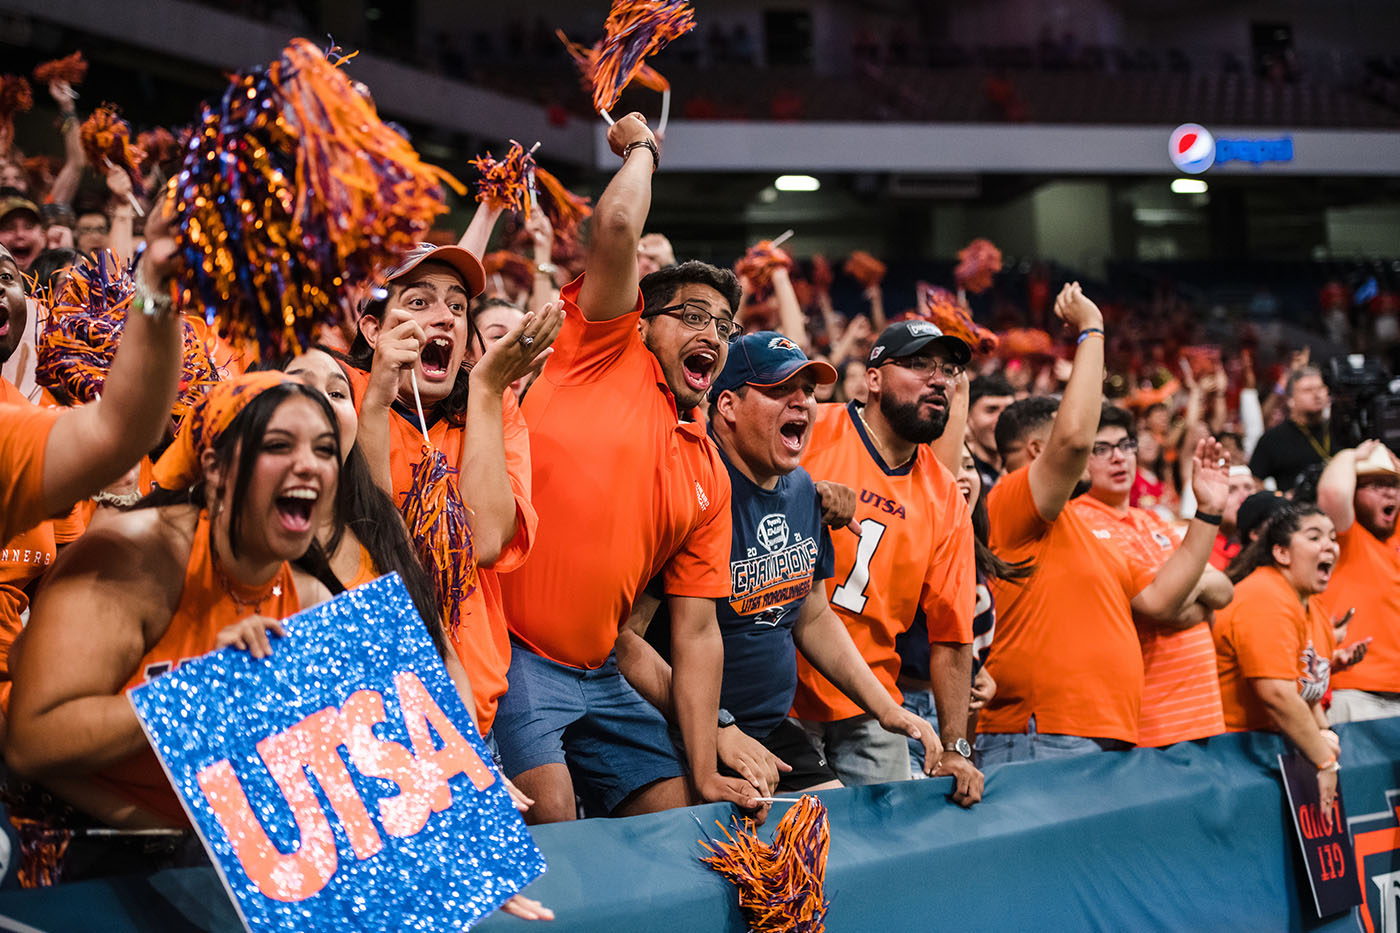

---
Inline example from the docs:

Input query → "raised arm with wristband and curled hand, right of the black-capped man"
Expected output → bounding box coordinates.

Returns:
[1030,282,1103,521]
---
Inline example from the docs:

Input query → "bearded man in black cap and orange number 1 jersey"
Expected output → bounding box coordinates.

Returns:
[792,321,981,807]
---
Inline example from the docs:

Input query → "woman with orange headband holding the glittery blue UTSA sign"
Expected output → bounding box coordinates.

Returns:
[6,373,340,828]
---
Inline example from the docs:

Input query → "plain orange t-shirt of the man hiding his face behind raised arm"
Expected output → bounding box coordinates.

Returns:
[977,467,1154,742]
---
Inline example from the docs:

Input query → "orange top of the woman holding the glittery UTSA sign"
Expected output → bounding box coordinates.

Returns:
[91,513,301,825]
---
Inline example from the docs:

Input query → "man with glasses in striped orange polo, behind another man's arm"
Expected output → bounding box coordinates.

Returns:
[1070,405,1232,748]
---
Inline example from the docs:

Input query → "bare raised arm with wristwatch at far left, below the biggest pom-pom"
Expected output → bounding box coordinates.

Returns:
[43,203,182,516]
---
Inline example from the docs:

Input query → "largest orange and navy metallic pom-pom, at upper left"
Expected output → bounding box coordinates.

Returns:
[171,39,466,357]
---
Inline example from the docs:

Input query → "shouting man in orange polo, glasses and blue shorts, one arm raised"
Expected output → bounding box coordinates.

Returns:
[496,113,759,822]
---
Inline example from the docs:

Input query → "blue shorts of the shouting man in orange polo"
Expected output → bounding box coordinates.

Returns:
[491,644,686,814]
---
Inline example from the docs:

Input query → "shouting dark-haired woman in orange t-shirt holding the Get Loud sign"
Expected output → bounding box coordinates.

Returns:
[1214,504,1341,813]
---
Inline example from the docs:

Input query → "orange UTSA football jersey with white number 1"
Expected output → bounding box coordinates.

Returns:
[792,402,977,723]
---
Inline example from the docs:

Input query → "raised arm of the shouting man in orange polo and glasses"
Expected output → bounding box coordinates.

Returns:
[578,113,657,321]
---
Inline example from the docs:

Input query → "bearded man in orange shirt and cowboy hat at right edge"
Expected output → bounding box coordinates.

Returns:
[1316,440,1400,724]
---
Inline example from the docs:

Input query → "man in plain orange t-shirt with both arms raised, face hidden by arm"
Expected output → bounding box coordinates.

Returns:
[977,283,1228,768]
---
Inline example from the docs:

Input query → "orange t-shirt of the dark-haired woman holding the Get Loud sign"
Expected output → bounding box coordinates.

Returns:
[1215,567,1334,733]
